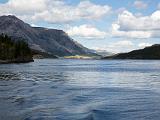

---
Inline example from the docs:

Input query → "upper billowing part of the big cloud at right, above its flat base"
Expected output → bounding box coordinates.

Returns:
[118,11,160,31]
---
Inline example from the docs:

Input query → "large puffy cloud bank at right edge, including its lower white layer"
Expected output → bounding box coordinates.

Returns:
[112,10,160,38]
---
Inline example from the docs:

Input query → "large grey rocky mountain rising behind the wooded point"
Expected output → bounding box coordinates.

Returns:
[0,15,92,56]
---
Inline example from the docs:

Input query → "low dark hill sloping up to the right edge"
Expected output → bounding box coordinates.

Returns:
[104,44,160,59]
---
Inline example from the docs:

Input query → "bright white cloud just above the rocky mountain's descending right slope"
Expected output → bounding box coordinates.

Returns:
[66,24,107,39]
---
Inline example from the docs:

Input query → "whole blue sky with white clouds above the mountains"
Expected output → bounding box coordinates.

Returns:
[0,0,160,53]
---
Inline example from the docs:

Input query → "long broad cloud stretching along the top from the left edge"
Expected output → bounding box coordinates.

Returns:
[0,0,111,23]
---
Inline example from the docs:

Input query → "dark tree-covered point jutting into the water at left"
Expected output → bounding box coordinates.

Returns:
[0,34,32,62]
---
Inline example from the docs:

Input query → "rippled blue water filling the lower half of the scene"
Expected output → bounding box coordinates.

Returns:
[0,59,160,120]
